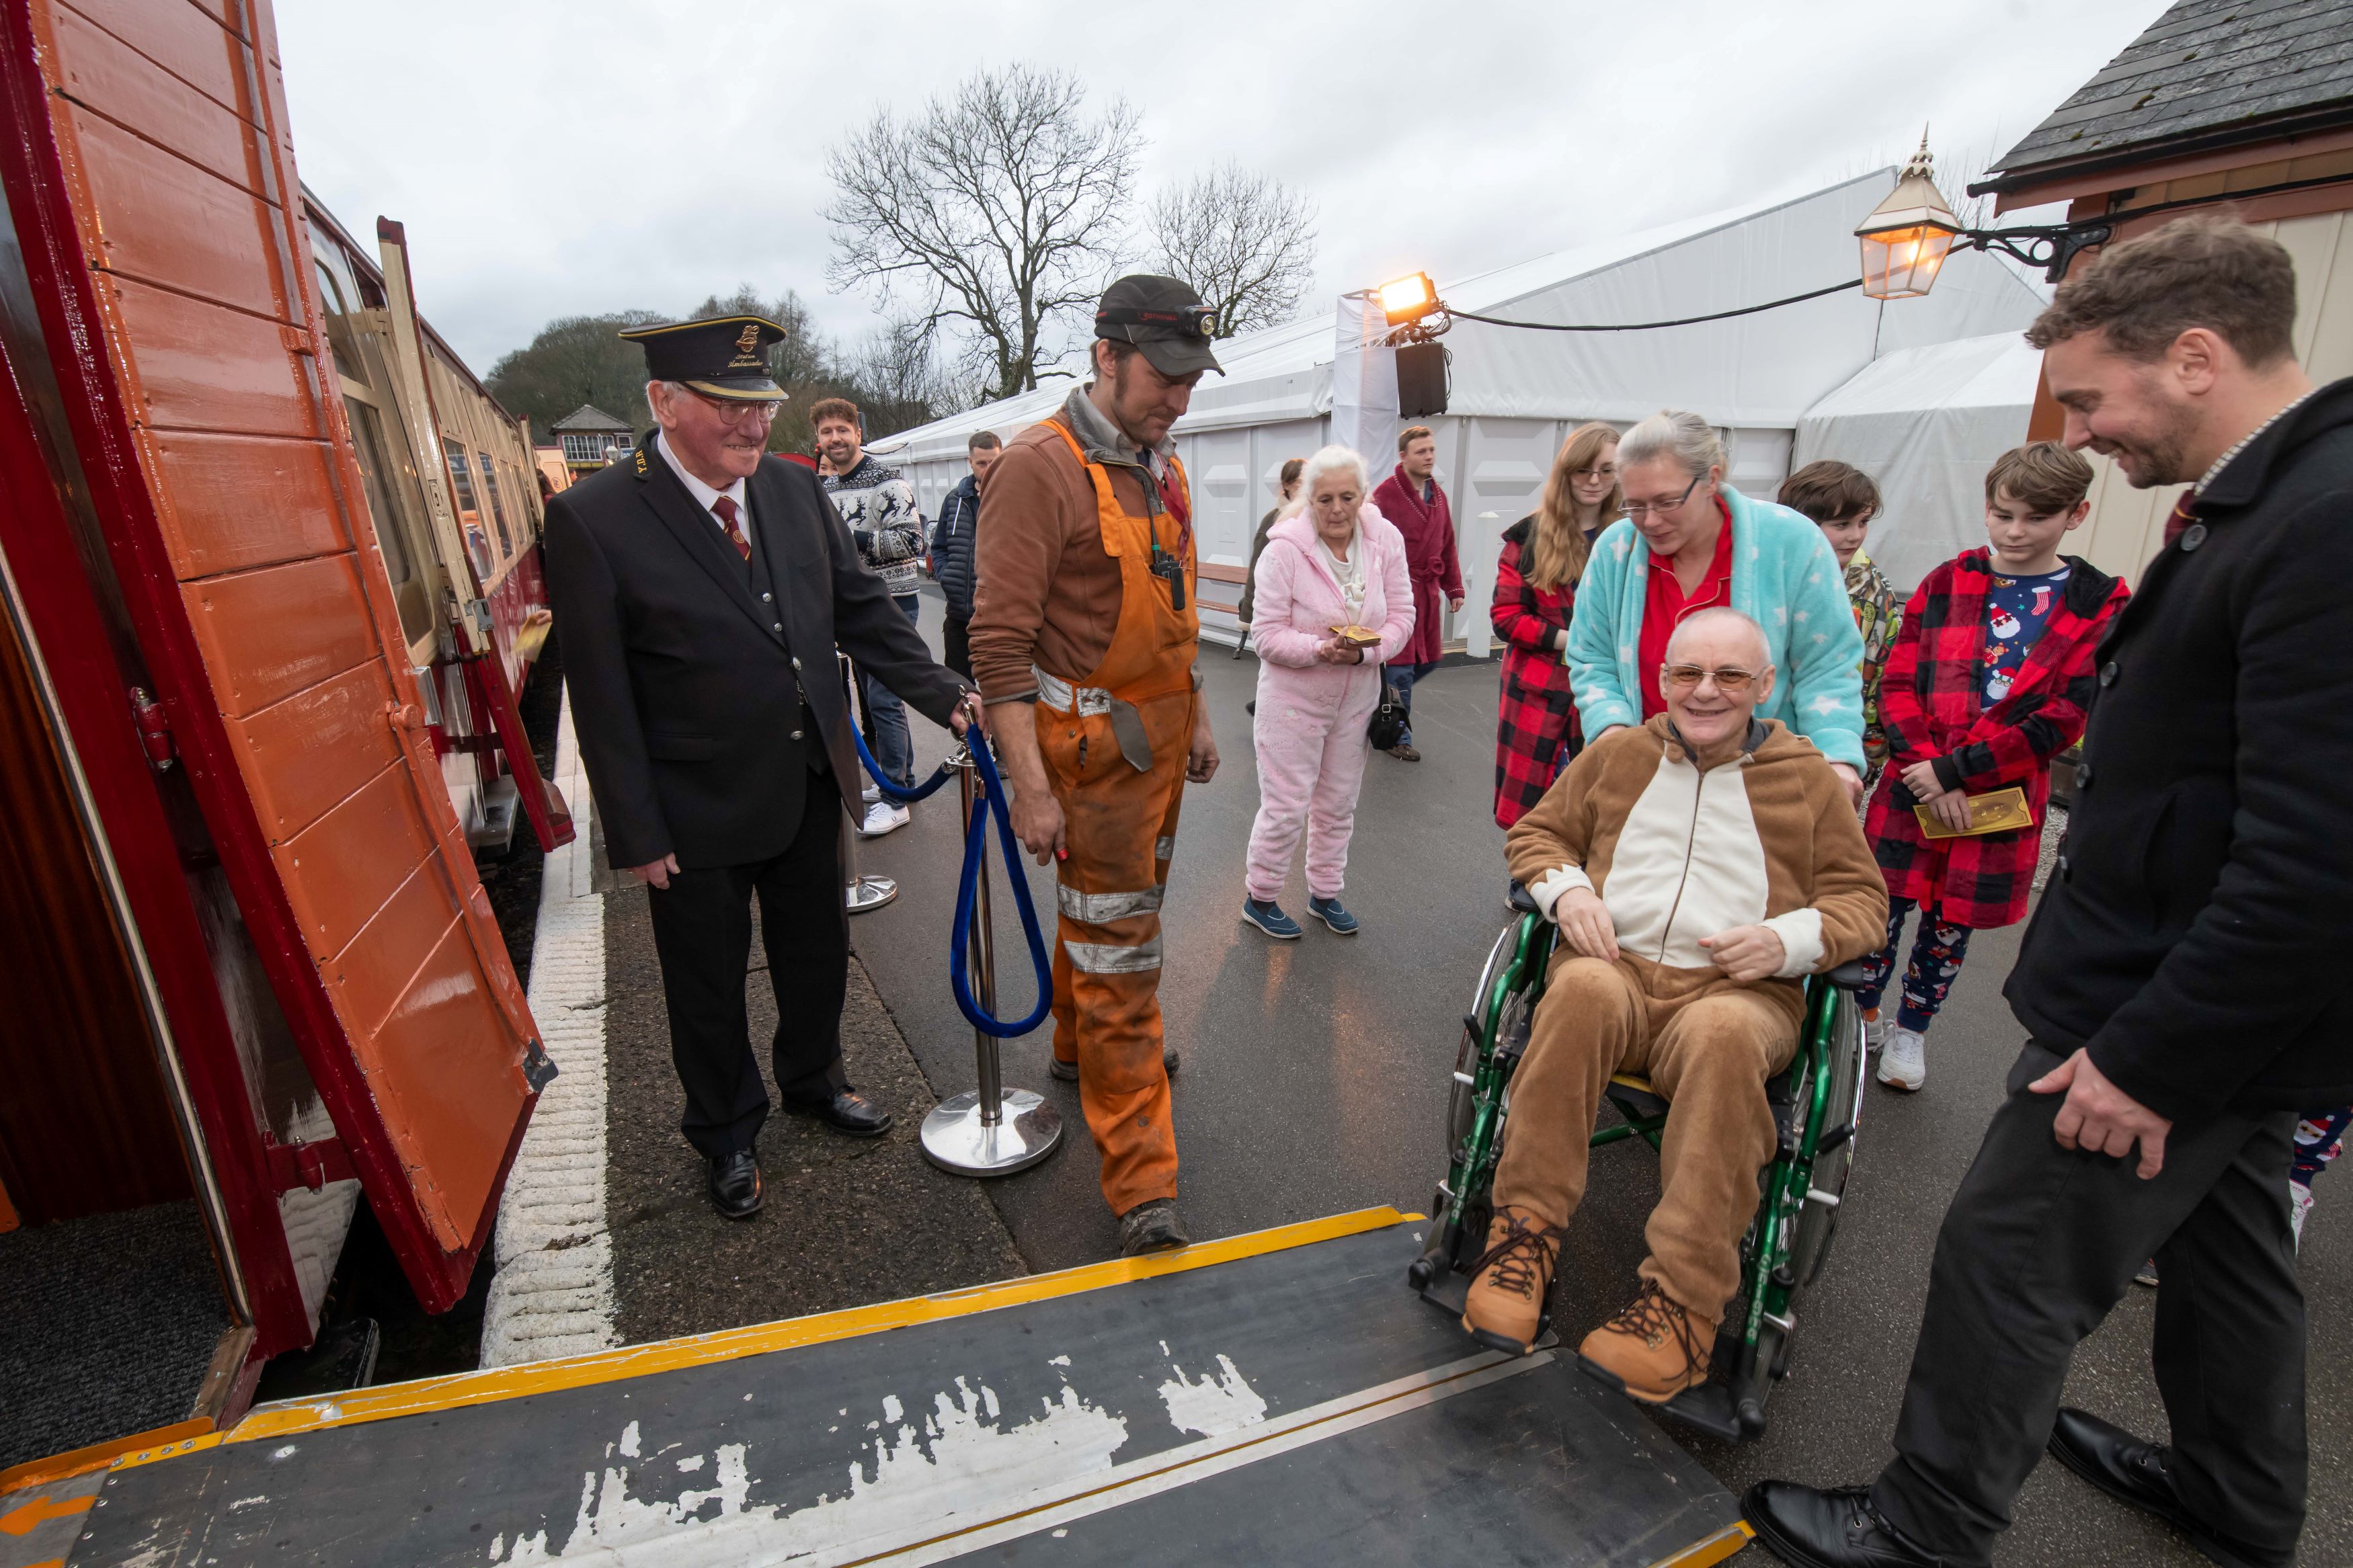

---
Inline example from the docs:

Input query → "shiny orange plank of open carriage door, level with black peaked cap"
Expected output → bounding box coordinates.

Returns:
[99,275,325,440]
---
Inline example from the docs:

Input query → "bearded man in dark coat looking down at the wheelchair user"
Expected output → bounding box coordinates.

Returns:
[1746,218,2353,1568]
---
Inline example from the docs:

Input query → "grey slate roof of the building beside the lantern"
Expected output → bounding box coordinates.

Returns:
[1970,0,2353,195]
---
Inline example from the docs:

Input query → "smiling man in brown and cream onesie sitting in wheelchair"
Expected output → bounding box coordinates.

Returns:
[1464,609,1887,1403]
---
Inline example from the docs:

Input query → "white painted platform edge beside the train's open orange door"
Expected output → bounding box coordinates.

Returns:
[483,691,619,1366]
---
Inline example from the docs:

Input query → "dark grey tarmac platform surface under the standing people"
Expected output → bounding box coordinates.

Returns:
[593,592,2353,1568]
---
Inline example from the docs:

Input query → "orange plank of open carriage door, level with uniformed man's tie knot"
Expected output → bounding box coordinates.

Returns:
[144,430,351,581]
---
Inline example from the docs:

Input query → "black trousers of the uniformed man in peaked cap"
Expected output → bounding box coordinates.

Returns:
[647,790,850,1159]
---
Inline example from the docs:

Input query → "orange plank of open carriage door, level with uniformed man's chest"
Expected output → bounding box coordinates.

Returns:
[182,552,379,717]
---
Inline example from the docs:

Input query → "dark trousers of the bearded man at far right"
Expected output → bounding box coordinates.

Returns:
[1871,1042,2306,1568]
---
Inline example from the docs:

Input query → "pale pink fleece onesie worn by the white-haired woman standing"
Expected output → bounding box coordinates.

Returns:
[1245,501,1414,901]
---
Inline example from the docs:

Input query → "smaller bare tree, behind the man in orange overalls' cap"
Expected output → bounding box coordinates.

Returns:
[1146,162,1316,339]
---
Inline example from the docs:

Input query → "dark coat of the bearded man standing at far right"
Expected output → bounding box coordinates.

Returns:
[2005,378,2353,1121]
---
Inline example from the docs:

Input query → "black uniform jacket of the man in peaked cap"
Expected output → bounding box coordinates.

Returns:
[544,435,965,868]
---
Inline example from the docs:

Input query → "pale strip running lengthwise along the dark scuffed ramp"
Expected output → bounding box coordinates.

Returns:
[859,1350,1553,1568]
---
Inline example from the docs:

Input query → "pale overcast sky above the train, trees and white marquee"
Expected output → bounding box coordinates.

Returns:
[278,0,2165,372]
